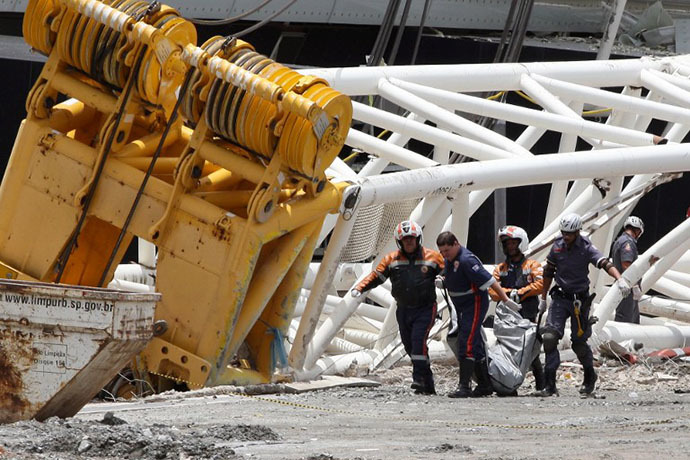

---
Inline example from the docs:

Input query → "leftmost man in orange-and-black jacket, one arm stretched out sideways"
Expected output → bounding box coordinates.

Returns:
[352,220,443,394]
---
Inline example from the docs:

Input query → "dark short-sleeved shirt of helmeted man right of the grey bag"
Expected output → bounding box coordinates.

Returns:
[546,235,606,294]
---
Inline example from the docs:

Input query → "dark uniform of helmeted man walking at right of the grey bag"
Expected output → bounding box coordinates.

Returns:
[544,235,606,372]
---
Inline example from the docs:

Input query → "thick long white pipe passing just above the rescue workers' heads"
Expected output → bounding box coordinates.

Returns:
[359,144,690,206]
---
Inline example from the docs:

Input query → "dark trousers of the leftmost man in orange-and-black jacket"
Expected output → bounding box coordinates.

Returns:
[396,303,436,382]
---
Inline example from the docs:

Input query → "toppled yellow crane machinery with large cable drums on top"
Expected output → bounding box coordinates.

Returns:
[0,0,352,391]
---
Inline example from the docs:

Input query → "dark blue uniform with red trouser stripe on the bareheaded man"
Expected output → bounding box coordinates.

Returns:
[443,247,495,361]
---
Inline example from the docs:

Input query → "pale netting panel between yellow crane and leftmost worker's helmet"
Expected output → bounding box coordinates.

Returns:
[340,200,419,262]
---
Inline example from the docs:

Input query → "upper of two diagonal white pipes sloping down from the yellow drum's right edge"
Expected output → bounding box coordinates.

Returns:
[352,101,515,163]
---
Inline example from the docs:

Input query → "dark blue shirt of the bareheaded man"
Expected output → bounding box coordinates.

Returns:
[443,247,494,296]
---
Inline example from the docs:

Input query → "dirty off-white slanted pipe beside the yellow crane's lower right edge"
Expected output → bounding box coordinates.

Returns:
[289,210,357,370]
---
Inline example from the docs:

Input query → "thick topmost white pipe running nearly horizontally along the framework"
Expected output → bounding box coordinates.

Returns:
[298,58,660,96]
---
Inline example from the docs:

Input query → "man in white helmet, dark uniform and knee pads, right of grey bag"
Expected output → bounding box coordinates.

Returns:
[539,214,630,396]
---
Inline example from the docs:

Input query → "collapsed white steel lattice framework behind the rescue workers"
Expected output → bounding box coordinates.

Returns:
[272,56,690,378]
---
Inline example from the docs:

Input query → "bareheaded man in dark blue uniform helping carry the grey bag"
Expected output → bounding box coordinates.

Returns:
[436,232,519,398]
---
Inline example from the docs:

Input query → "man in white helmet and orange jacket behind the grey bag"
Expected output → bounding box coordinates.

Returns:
[489,225,544,391]
